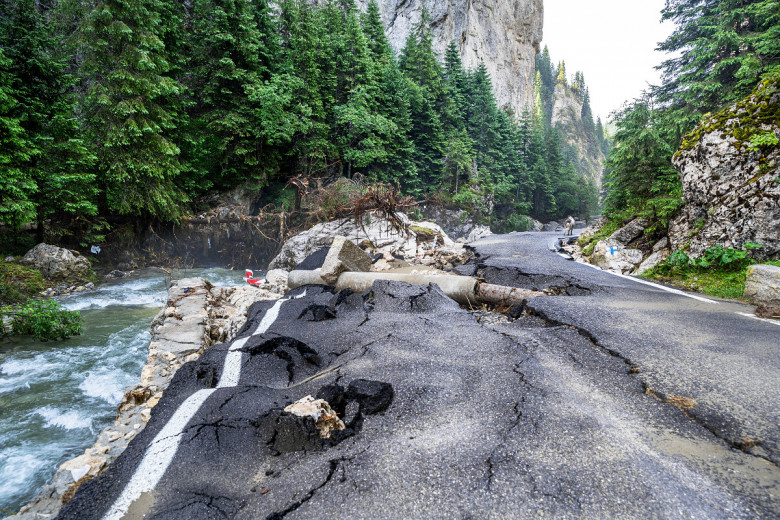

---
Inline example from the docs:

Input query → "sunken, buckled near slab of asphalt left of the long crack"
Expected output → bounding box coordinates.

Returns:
[59,281,780,519]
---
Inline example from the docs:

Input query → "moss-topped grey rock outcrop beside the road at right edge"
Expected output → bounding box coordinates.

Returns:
[669,79,780,258]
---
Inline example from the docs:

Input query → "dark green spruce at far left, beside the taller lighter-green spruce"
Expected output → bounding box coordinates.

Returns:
[0,0,97,241]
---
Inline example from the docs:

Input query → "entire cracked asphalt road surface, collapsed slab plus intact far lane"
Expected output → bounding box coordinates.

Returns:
[58,234,780,519]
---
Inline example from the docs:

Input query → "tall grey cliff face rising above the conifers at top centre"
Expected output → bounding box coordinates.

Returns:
[358,0,544,114]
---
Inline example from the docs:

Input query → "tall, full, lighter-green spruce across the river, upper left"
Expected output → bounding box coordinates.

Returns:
[81,0,186,219]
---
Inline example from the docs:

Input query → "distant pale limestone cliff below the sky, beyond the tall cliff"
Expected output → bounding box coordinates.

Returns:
[551,84,605,187]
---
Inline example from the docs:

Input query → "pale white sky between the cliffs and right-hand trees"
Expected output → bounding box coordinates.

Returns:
[542,0,674,121]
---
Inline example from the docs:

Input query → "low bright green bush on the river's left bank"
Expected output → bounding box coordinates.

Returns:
[0,299,81,341]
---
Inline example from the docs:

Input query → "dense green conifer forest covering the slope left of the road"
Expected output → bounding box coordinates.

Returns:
[0,0,597,236]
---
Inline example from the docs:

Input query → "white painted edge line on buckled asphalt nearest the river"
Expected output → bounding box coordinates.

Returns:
[103,291,306,520]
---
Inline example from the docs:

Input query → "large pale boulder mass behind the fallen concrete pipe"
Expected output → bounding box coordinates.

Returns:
[268,213,454,271]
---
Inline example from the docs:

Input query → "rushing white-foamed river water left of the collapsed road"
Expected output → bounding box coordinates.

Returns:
[0,268,243,518]
